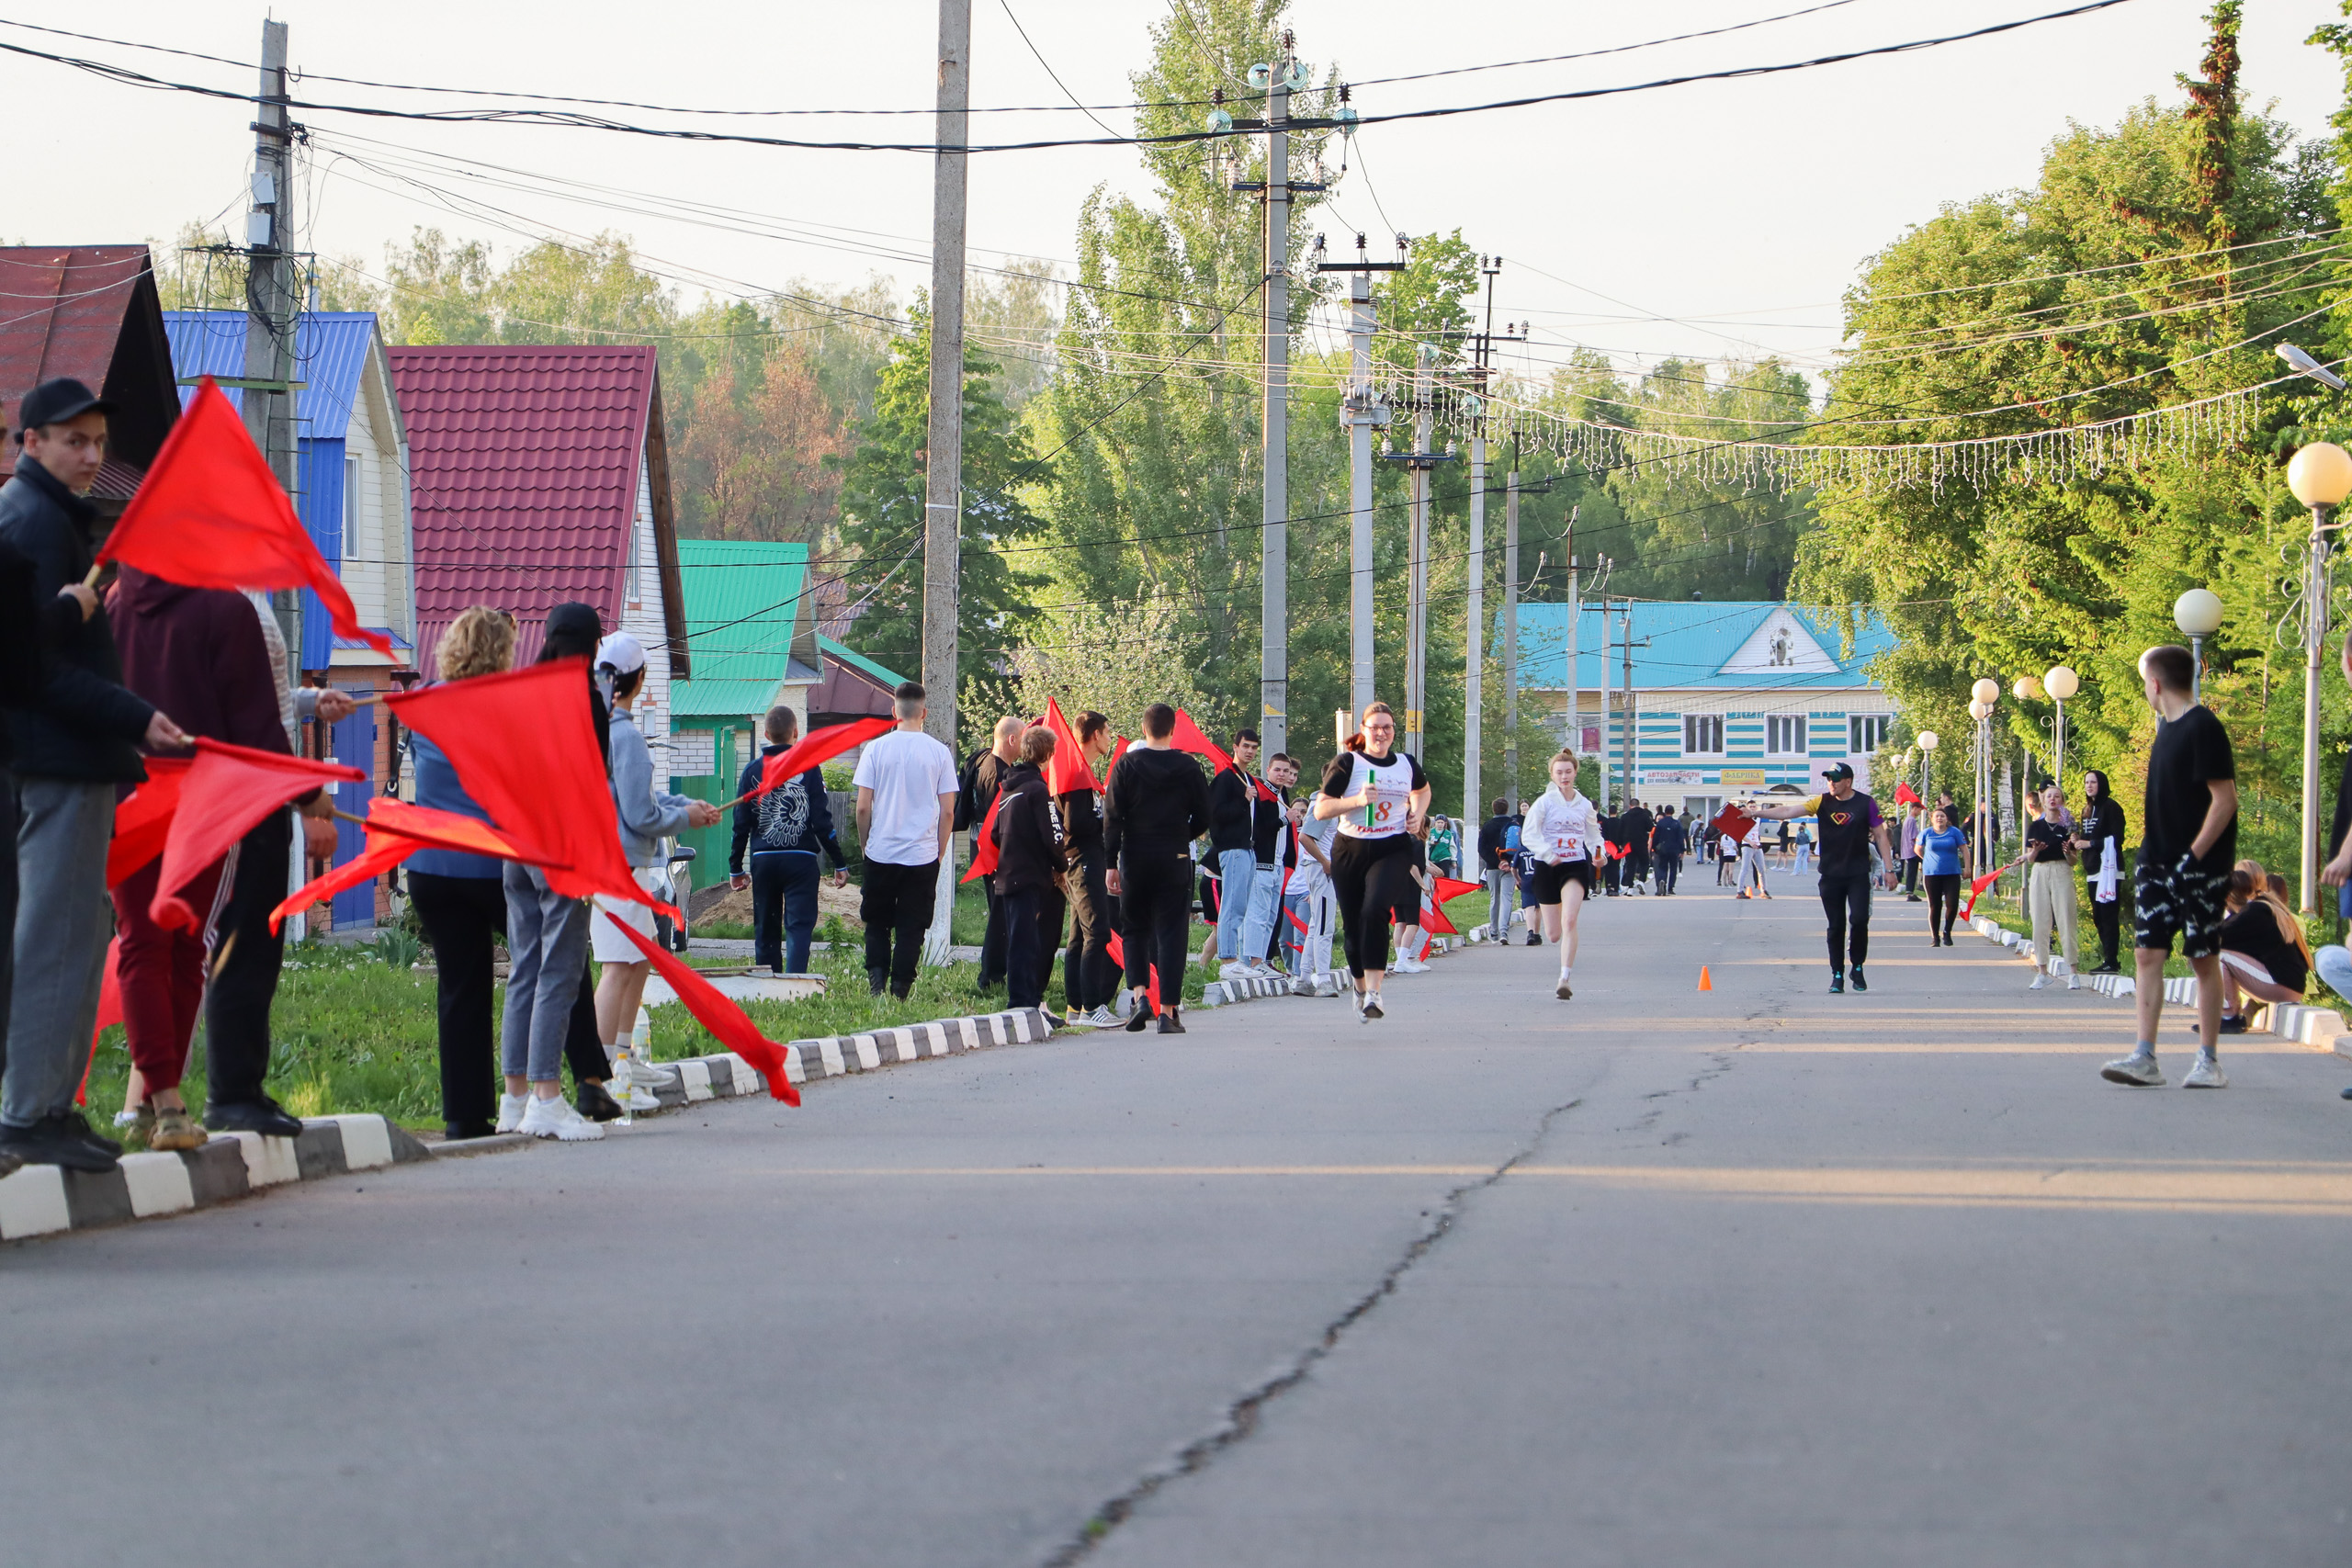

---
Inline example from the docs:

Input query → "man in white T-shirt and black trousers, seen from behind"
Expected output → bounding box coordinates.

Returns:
[856,682,957,1001]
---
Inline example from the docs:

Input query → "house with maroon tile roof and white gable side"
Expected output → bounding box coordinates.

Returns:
[388,344,692,773]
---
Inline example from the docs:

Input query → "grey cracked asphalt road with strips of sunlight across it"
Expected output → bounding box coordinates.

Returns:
[0,877,2352,1568]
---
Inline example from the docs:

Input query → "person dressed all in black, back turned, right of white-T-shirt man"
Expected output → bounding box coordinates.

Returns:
[1103,703,1209,1034]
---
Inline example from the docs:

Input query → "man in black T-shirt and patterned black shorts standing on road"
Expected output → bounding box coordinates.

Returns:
[2098,644,2237,1089]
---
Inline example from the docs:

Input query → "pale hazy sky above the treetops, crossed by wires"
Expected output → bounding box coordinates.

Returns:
[0,0,2343,388]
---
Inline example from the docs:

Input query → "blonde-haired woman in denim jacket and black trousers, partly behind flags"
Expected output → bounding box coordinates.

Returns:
[404,604,515,1143]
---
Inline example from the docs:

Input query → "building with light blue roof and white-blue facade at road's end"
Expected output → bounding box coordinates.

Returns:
[1520,600,1894,816]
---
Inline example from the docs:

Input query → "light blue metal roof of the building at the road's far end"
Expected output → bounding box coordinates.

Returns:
[1494,600,1895,691]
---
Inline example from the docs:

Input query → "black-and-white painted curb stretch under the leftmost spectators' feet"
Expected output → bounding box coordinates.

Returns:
[0,1114,433,1241]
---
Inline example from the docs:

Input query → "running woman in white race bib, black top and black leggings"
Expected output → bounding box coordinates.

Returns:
[1315,703,1430,1022]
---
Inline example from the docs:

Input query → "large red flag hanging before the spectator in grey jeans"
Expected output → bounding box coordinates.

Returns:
[383,659,677,919]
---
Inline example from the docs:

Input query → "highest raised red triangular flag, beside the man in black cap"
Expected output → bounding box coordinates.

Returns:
[99,376,393,656]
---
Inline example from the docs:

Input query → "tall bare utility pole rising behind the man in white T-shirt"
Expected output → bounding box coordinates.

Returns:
[922,0,971,966]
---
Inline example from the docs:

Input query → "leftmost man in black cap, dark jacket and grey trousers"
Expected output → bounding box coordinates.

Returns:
[0,381,188,1170]
